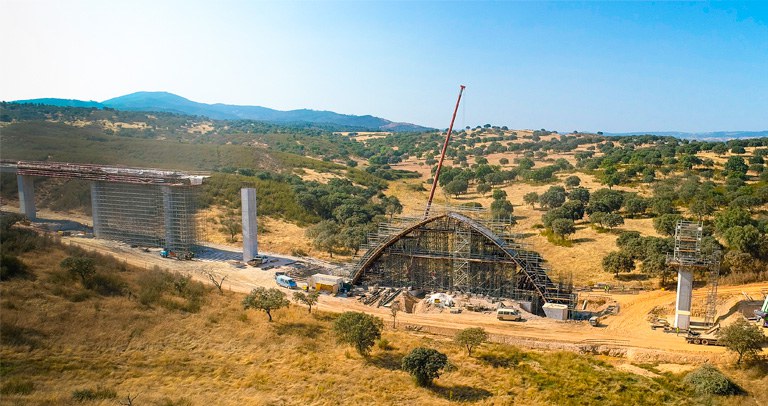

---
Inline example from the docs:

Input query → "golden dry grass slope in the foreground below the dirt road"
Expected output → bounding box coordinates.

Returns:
[0,243,765,405]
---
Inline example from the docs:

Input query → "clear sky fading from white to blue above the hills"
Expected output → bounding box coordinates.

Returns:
[0,0,768,132]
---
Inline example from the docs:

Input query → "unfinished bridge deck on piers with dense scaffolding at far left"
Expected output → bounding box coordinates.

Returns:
[0,160,208,253]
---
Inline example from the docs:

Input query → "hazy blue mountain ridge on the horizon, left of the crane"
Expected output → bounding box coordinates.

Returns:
[16,92,431,131]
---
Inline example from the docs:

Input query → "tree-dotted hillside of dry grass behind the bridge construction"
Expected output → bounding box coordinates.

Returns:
[0,104,768,288]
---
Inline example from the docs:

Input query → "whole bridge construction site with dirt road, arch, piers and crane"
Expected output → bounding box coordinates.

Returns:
[2,86,768,360]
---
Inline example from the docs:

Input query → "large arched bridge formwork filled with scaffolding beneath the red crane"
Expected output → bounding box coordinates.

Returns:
[352,211,575,313]
